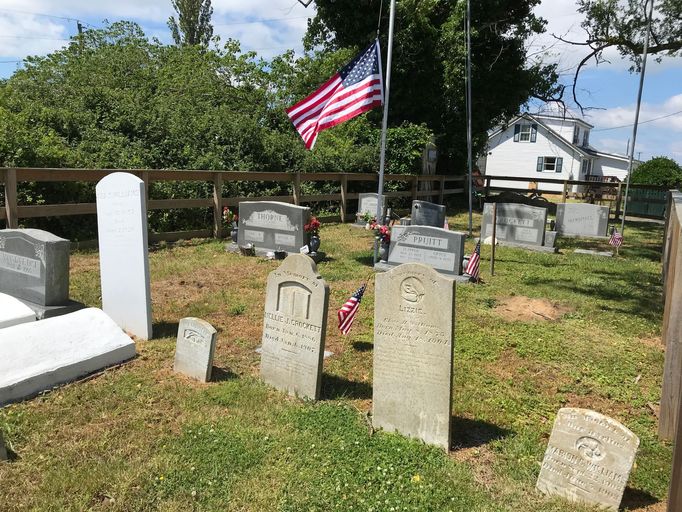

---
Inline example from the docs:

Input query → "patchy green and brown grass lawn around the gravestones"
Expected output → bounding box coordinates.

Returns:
[0,209,672,512]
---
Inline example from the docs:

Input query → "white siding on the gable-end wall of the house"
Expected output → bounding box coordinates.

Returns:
[485,120,581,192]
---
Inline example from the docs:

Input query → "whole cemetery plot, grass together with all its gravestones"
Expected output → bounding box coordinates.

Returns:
[0,178,682,512]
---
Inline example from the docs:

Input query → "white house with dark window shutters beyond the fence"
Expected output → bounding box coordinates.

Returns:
[478,114,639,192]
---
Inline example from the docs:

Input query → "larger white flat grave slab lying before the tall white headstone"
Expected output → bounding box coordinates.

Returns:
[0,308,135,406]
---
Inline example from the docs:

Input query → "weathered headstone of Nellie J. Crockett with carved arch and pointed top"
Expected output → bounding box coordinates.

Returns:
[260,254,329,399]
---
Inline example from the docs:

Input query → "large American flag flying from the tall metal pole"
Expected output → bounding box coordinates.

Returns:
[286,39,384,149]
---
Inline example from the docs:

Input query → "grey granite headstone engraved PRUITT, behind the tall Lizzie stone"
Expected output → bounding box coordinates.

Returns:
[378,225,466,275]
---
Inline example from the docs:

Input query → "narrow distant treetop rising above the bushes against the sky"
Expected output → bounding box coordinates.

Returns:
[168,0,213,47]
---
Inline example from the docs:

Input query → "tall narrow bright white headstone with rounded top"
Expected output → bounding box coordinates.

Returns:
[96,172,152,340]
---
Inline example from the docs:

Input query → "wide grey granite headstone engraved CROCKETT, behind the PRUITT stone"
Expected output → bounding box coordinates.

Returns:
[481,203,547,246]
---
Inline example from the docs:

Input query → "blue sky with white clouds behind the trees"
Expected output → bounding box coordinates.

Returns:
[0,0,682,163]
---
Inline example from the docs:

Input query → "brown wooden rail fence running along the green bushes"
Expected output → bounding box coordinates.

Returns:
[0,168,465,241]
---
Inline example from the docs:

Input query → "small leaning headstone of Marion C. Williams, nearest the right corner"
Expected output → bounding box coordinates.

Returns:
[536,407,639,511]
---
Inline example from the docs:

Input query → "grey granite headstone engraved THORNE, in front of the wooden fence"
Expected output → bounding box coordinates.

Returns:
[239,201,310,254]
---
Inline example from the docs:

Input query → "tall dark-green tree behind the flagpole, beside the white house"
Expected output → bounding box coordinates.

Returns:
[305,0,562,170]
